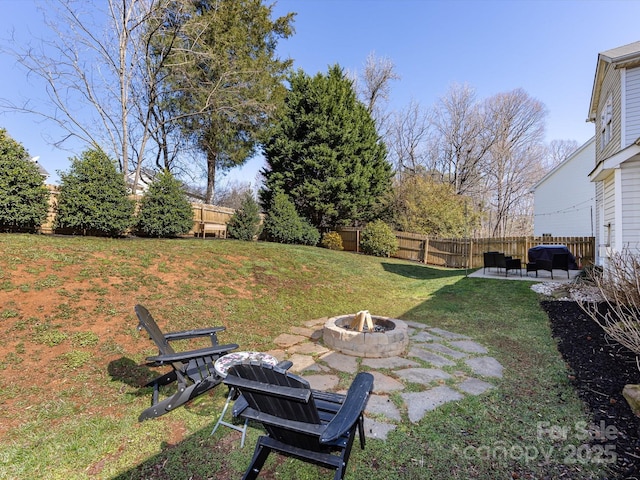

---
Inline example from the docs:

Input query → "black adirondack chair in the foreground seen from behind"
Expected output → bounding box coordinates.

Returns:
[224,363,373,480]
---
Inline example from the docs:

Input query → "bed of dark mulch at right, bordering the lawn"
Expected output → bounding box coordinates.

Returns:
[542,301,640,480]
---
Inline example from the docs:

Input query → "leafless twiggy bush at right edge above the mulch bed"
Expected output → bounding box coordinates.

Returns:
[580,250,640,355]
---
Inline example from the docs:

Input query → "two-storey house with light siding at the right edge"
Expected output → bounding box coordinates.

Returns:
[587,42,640,265]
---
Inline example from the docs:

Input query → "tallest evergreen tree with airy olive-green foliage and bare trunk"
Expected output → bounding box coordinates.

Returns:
[156,0,293,203]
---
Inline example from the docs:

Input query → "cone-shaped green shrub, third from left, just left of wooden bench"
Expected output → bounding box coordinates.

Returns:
[138,170,193,238]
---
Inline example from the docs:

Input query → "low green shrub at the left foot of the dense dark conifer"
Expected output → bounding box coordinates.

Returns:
[264,192,320,245]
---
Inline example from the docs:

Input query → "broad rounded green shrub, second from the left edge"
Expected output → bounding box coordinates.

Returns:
[56,149,134,237]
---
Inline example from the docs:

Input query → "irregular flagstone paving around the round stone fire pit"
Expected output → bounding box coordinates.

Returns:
[268,318,502,440]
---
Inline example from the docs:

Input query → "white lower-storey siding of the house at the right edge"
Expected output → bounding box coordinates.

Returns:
[616,161,640,250]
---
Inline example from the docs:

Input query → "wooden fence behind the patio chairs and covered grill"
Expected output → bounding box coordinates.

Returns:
[337,227,595,268]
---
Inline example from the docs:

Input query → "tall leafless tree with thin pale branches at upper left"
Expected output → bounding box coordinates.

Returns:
[2,0,164,178]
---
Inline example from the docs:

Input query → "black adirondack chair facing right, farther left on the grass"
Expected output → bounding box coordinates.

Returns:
[135,305,238,422]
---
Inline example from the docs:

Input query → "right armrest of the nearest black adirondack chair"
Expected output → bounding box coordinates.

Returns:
[320,372,373,443]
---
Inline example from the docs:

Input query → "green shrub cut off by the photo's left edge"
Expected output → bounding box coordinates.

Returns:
[0,128,49,230]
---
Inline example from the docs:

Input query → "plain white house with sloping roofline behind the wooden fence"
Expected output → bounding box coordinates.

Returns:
[532,137,596,237]
